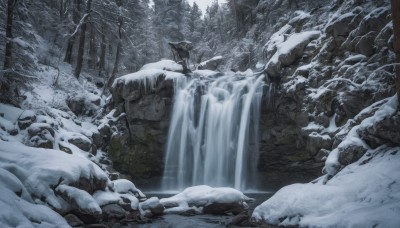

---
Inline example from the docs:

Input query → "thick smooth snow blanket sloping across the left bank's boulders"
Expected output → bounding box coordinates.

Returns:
[0,141,107,209]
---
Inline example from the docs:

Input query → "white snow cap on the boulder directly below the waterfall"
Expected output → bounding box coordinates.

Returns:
[160,185,253,213]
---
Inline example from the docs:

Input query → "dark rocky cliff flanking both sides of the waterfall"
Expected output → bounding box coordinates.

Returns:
[108,1,395,188]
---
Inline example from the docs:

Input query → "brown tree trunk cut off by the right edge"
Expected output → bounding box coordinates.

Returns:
[391,0,400,107]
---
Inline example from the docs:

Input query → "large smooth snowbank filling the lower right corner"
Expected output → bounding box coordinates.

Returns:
[252,145,400,227]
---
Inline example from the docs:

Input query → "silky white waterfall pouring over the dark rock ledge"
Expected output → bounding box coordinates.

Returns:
[162,71,264,190]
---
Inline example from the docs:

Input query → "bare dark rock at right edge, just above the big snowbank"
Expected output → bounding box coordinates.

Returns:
[357,112,400,148]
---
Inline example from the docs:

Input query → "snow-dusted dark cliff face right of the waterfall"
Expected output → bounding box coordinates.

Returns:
[255,1,395,189]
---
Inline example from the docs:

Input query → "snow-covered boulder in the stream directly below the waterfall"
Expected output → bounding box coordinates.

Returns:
[160,185,253,214]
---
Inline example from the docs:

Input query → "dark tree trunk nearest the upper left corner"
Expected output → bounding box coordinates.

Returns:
[3,0,16,70]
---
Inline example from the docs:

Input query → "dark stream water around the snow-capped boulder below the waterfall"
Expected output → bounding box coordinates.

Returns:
[120,193,273,228]
